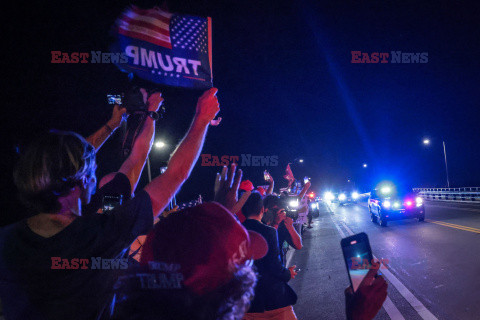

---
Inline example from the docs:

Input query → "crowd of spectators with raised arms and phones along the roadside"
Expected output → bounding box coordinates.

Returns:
[0,88,387,320]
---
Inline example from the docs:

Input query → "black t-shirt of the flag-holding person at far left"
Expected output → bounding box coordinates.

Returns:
[0,174,153,320]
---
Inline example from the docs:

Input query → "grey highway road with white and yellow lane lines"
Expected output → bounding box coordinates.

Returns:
[287,202,480,320]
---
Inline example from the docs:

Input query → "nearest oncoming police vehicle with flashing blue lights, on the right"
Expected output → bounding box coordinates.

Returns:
[368,186,425,227]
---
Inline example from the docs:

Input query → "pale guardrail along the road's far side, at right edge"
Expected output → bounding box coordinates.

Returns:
[413,187,480,203]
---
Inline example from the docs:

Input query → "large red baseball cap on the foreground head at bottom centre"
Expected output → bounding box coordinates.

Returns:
[140,202,268,295]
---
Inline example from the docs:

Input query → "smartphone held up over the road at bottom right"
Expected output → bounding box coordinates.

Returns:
[340,232,374,292]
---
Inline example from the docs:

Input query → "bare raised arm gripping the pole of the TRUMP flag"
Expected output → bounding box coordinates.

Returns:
[144,88,220,216]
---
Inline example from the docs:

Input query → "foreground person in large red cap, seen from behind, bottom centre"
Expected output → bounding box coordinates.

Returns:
[113,202,268,320]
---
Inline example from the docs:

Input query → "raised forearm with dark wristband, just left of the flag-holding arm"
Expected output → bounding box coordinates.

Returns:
[119,89,163,193]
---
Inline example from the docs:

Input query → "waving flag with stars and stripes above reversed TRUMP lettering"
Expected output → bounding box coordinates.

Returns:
[112,6,212,89]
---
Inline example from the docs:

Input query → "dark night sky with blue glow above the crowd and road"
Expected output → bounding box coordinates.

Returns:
[2,0,480,225]
